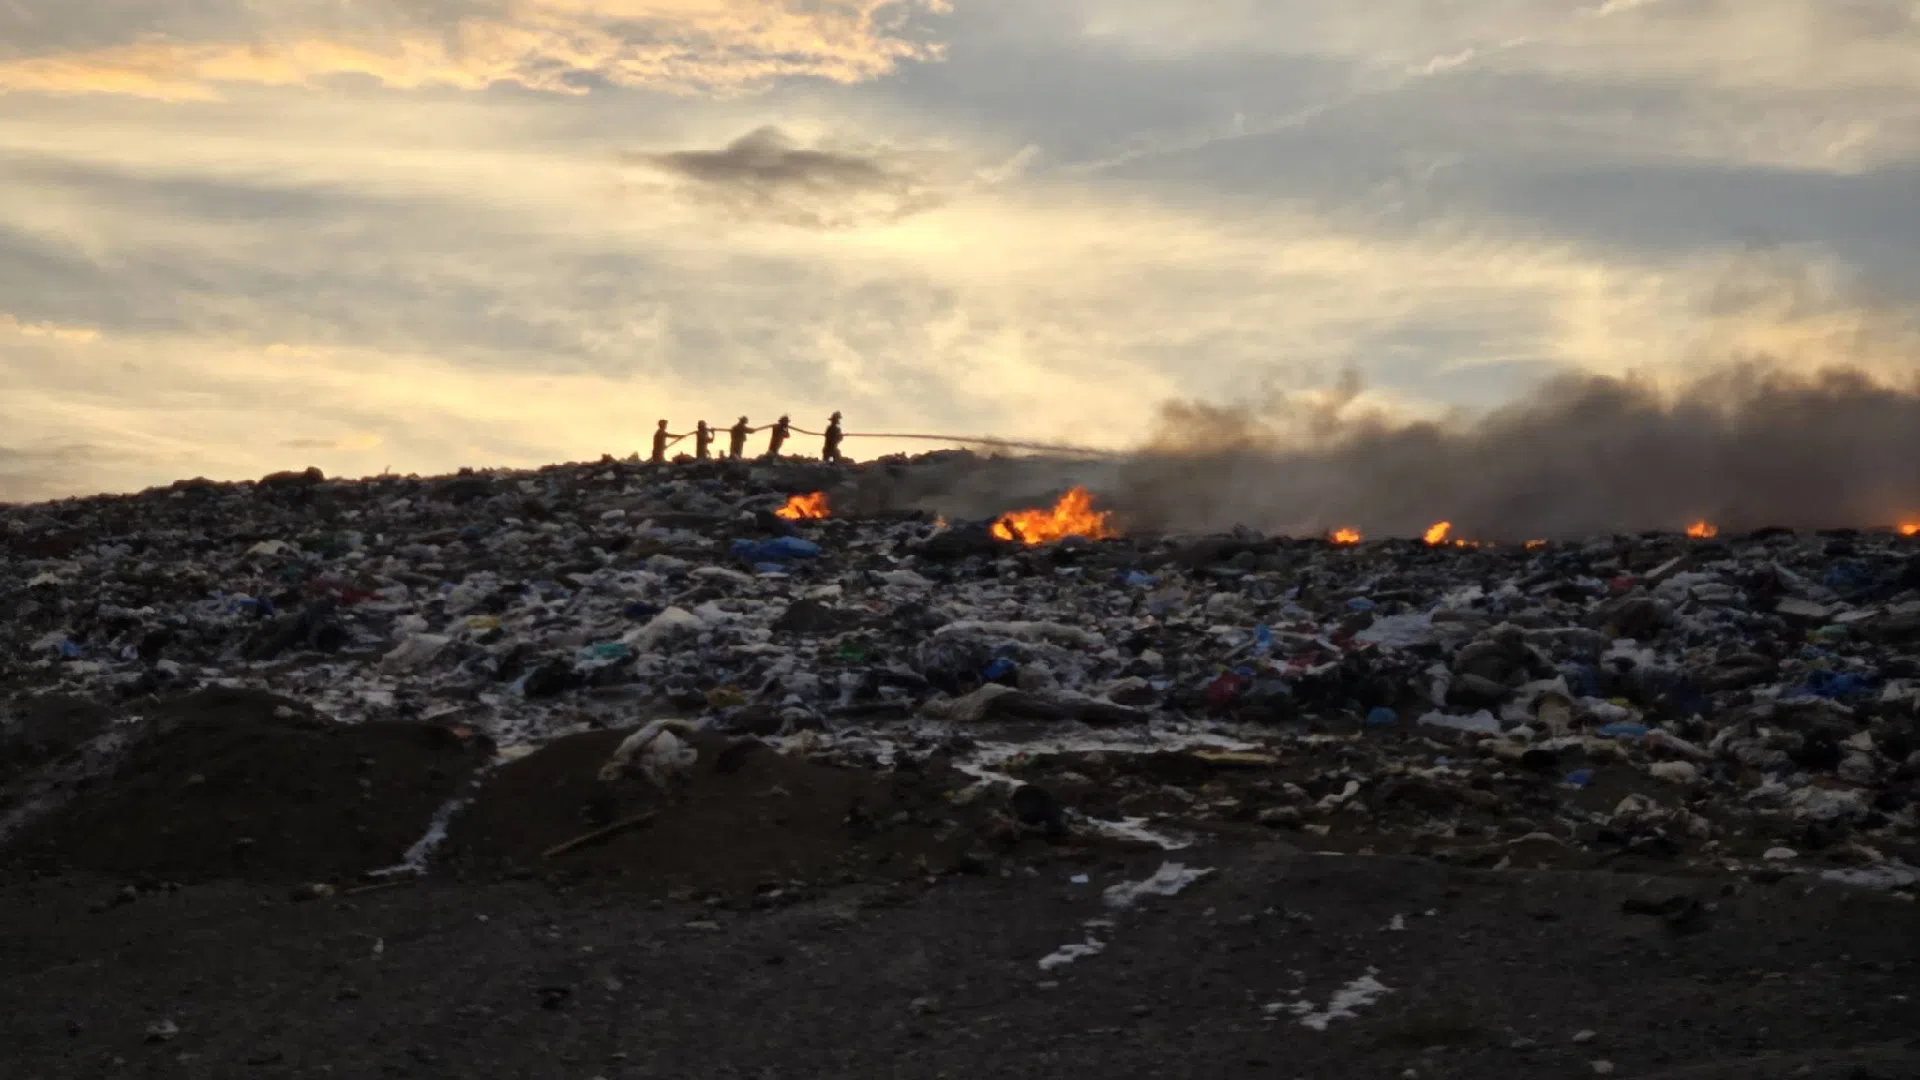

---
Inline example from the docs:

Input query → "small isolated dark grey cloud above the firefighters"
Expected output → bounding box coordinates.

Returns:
[626,127,964,229]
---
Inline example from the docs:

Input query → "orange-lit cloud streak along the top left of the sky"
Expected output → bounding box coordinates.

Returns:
[0,0,947,102]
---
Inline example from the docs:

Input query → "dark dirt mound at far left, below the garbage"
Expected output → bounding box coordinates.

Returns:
[12,690,492,882]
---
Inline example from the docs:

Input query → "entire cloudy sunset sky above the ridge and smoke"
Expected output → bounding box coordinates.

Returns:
[0,0,1920,500]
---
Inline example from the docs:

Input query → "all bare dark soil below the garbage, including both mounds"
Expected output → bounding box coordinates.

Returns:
[0,690,1920,1080]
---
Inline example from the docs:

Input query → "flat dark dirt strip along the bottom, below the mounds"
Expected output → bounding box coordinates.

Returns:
[0,846,1920,1080]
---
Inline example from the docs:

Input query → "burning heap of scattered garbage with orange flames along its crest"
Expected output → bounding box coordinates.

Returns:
[0,449,1920,890]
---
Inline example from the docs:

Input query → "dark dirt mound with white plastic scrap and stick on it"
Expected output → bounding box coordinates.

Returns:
[438,732,1044,896]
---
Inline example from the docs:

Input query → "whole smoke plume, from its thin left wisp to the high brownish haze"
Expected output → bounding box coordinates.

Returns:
[900,252,1920,542]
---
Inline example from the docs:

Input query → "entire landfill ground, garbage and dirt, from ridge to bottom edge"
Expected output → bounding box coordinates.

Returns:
[0,455,1920,1078]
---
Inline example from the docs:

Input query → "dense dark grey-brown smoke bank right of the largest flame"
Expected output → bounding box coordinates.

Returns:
[1110,361,1920,540]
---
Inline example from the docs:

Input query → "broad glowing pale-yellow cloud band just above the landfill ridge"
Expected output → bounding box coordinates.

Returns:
[0,116,1904,488]
